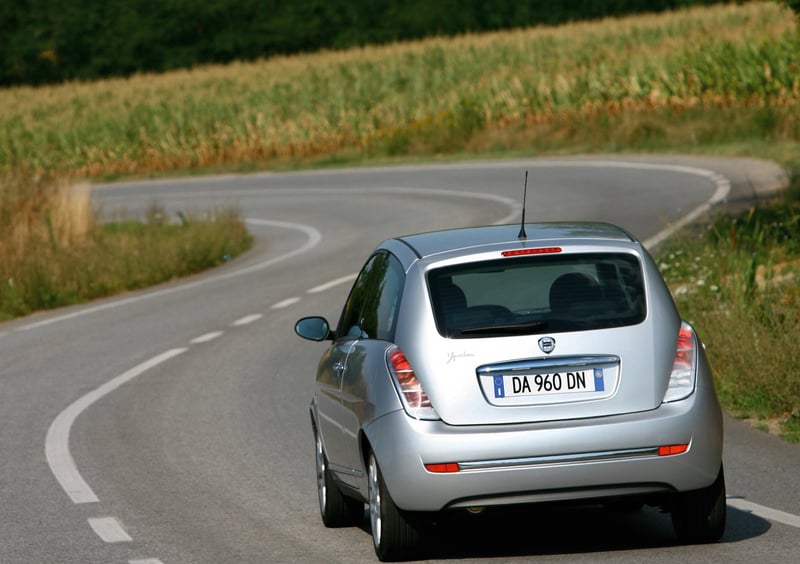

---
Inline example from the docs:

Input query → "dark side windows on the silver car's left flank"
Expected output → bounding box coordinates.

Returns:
[336,252,405,341]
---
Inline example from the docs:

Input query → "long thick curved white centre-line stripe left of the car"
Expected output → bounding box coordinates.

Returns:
[44,348,188,503]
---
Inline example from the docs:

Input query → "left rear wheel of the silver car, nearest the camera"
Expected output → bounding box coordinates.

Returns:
[368,452,419,562]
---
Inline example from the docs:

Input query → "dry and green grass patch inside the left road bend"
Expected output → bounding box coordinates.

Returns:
[0,167,252,320]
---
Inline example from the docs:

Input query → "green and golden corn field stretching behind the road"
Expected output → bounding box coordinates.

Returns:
[0,2,800,177]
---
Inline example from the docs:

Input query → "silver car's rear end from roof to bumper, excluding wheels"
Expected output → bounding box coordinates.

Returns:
[365,224,722,511]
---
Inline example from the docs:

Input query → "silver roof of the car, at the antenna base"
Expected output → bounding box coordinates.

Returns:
[383,222,636,259]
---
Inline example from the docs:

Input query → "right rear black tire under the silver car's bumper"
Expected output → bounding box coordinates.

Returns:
[672,466,727,544]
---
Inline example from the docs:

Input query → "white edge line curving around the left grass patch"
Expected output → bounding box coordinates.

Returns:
[15,218,322,331]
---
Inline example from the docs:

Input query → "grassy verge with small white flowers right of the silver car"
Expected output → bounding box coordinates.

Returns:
[657,175,800,443]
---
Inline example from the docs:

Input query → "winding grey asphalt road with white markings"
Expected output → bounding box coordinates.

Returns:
[0,157,800,564]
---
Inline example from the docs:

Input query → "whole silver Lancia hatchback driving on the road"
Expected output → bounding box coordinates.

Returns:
[295,223,726,560]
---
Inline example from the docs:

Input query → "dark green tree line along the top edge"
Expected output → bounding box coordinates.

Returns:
[0,0,752,86]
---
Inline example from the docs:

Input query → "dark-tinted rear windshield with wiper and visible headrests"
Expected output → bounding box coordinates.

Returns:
[428,253,645,338]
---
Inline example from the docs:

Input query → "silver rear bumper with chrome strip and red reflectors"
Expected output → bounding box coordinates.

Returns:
[364,387,722,511]
